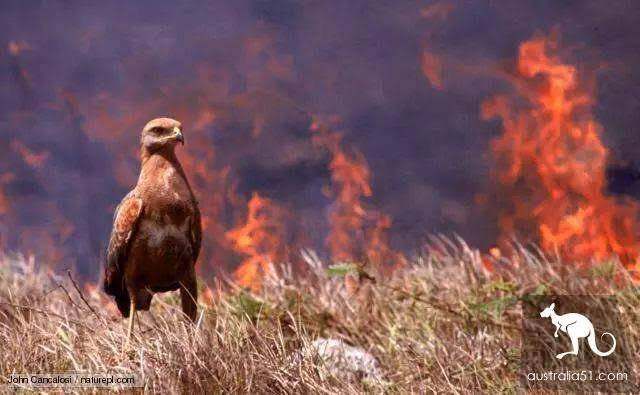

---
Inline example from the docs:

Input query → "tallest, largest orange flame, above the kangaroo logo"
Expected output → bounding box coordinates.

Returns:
[481,33,639,272]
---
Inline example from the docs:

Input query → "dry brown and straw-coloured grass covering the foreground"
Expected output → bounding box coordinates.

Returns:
[0,239,640,393]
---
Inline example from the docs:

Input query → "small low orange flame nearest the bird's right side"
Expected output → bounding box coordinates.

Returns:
[227,192,285,290]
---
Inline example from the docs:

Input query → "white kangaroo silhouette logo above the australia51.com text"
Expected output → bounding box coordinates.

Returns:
[540,303,616,359]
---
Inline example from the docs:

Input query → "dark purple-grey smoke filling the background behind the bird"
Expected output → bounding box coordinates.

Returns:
[0,0,640,278]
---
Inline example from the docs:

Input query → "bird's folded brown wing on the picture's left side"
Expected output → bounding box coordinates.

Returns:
[103,189,142,298]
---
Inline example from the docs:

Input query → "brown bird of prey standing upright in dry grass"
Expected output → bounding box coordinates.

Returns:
[103,118,202,344]
